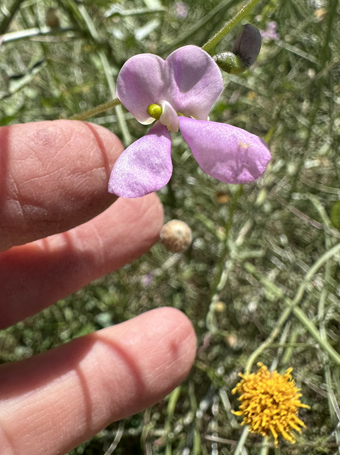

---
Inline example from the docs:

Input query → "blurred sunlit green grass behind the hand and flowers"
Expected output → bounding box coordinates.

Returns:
[0,0,340,455]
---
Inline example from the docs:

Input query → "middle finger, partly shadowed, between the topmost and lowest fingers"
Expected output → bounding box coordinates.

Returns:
[0,194,163,329]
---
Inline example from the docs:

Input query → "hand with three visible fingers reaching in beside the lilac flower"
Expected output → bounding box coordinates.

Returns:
[0,120,196,455]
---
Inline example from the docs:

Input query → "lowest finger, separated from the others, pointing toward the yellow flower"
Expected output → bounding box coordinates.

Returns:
[0,308,196,455]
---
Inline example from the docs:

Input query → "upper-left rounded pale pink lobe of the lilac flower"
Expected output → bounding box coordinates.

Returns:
[116,54,168,125]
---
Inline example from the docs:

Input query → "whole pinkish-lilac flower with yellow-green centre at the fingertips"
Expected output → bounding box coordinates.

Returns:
[109,46,270,198]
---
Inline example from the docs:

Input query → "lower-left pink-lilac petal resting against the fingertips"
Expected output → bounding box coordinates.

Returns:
[109,122,172,198]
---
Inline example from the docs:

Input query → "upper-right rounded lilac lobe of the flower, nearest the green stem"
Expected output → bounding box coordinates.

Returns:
[165,45,223,120]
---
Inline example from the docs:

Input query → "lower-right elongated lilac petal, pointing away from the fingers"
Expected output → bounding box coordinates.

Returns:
[179,117,270,183]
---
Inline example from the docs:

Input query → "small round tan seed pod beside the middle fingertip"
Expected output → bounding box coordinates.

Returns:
[160,220,192,253]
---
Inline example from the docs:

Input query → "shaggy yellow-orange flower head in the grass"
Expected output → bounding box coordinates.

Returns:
[232,363,309,445]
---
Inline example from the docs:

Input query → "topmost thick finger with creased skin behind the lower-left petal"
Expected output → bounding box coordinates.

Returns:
[0,120,123,251]
